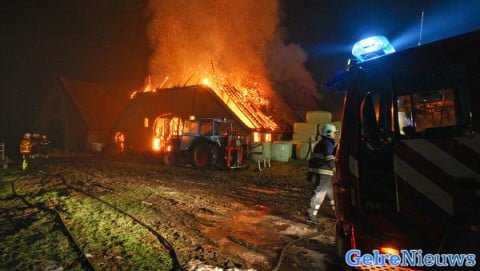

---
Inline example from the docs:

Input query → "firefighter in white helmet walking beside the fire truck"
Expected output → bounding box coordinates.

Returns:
[307,124,337,223]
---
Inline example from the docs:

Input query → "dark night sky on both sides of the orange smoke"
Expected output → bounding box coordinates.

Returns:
[0,0,480,155]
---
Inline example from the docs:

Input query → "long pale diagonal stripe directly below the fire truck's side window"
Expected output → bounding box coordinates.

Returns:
[403,139,478,179]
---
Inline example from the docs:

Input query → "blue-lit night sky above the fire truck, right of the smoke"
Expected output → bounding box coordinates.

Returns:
[284,0,480,83]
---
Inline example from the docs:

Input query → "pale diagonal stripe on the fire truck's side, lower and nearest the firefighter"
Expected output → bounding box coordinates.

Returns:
[394,155,454,215]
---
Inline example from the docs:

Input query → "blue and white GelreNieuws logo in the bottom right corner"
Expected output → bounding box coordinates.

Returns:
[345,249,477,267]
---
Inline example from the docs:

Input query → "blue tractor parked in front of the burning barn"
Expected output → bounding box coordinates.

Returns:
[164,118,245,169]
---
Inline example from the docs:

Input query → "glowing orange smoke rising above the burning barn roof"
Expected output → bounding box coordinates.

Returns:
[148,0,316,125]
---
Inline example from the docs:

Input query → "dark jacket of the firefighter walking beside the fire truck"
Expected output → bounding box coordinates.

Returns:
[308,136,336,176]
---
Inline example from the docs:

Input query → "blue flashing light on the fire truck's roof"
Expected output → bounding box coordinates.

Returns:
[352,36,395,62]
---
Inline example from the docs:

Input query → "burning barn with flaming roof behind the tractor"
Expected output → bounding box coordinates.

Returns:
[112,81,295,152]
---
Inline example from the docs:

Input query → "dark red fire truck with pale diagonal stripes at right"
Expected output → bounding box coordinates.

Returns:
[330,31,480,264]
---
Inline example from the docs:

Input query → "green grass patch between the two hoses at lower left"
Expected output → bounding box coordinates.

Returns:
[65,198,172,270]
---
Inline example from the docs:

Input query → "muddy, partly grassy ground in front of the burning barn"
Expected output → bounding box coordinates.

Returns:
[0,157,344,270]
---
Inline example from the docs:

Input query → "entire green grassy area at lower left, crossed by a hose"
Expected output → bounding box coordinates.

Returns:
[0,178,173,270]
